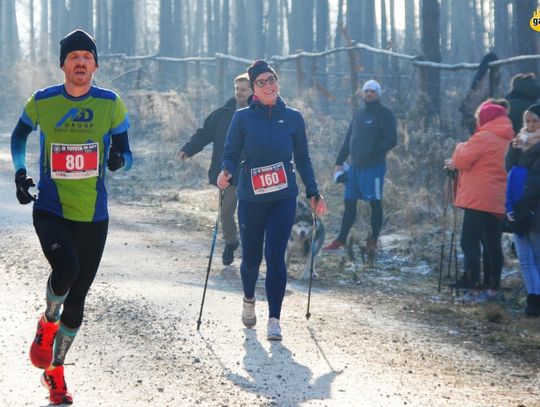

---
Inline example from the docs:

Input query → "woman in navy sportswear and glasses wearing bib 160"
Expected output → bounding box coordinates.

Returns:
[217,60,326,341]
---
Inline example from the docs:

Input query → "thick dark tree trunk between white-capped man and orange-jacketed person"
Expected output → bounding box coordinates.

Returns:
[419,0,441,118]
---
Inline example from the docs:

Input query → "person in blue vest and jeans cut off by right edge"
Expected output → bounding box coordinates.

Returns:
[505,104,540,317]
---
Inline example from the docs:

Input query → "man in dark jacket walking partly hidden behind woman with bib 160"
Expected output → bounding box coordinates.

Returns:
[178,74,251,266]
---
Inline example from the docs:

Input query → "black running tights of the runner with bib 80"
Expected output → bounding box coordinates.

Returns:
[33,210,109,329]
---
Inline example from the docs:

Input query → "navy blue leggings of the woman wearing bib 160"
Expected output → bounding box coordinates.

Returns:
[238,198,296,319]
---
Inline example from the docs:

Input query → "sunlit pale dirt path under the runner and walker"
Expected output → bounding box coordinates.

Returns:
[0,132,540,407]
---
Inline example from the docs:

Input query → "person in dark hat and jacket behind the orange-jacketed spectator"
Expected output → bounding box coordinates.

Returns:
[506,73,540,134]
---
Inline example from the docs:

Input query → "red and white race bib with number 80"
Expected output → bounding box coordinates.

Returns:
[51,143,99,179]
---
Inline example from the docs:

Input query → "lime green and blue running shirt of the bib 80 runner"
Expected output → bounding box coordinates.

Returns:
[12,85,131,222]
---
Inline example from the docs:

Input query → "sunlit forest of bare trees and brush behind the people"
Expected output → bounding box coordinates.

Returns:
[0,0,540,286]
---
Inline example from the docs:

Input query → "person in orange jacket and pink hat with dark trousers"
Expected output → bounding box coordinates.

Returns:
[445,99,514,300]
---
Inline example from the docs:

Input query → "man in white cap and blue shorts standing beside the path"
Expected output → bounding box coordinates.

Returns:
[325,79,397,260]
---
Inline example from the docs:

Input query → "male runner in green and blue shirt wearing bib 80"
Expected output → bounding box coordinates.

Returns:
[11,30,132,405]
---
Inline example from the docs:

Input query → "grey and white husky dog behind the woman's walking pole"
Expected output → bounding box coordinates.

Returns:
[285,200,325,280]
